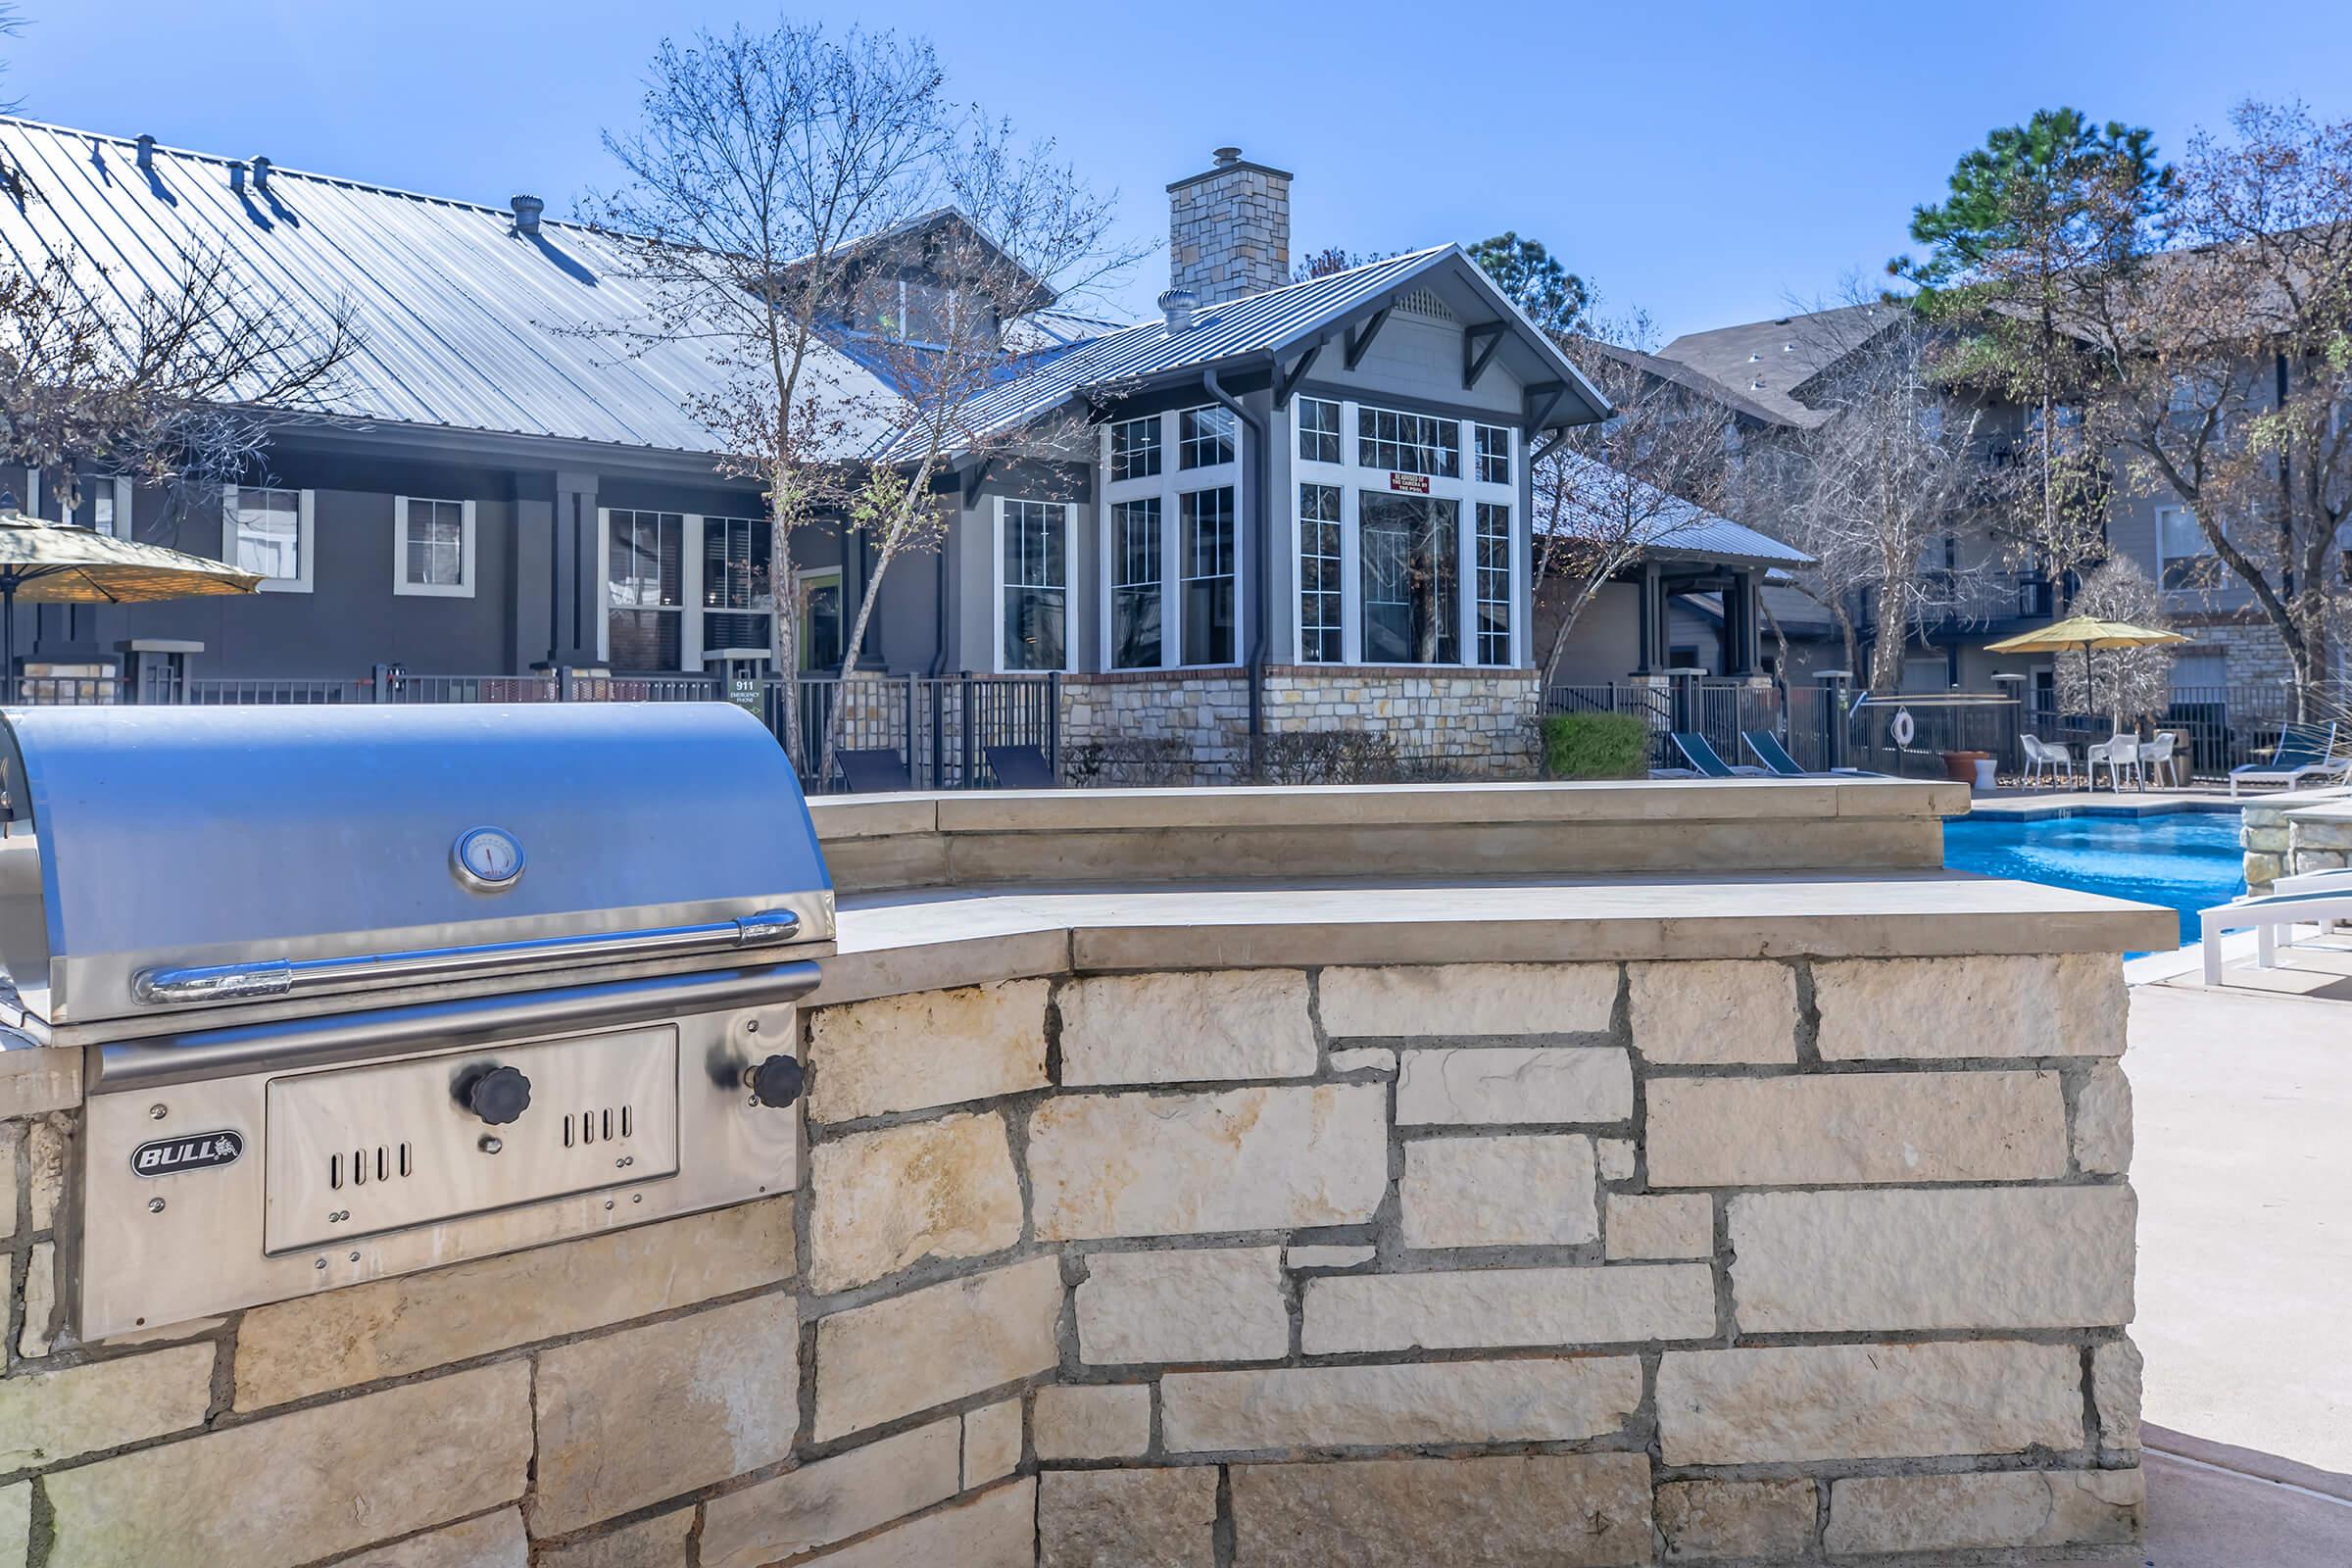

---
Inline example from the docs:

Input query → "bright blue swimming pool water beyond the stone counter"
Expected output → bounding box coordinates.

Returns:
[1942,811,2246,943]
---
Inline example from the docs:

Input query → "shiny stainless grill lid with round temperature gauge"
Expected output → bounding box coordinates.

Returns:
[0,703,833,1025]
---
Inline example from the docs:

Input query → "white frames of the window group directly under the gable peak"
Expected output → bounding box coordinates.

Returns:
[1298,393,1529,672]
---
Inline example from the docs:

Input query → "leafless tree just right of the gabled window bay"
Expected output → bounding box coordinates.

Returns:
[1534,313,1729,684]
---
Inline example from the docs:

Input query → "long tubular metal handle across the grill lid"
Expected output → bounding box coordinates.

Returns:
[131,909,800,1006]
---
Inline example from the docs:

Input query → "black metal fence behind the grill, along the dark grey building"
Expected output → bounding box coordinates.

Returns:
[14,665,1063,792]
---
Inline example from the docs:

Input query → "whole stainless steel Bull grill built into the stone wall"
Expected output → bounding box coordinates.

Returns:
[0,703,833,1338]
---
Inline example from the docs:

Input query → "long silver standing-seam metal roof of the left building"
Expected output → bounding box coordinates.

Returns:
[0,118,904,454]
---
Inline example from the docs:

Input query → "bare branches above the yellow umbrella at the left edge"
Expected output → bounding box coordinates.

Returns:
[0,242,360,519]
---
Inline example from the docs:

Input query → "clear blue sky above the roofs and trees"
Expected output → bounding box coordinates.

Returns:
[5,0,2352,336]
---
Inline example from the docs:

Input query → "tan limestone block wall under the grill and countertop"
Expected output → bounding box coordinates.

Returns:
[0,956,2142,1568]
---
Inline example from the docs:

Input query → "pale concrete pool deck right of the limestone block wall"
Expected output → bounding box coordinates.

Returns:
[2100,973,2352,1568]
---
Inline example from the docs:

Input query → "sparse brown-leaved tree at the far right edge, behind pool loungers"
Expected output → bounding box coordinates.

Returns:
[2072,104,2352,706]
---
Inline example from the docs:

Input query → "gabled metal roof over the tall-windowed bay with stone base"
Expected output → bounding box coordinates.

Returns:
[917,244,1609,453]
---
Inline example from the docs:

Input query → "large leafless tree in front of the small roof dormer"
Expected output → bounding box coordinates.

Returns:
[588,22,1133,766]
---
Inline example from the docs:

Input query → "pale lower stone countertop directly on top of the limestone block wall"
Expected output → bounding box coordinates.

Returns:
[811,872,2178,1004]
